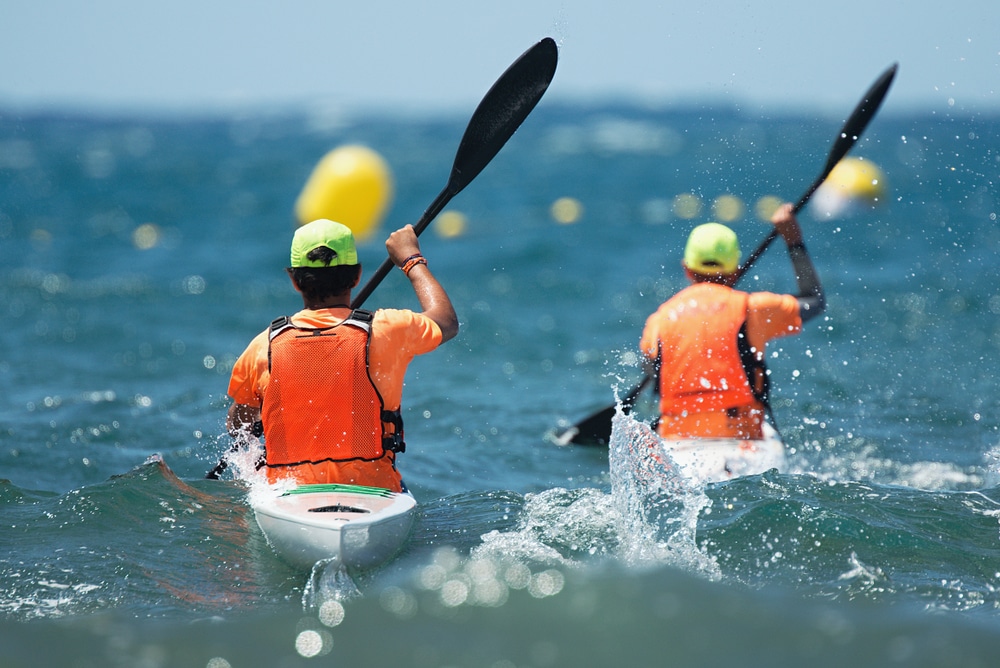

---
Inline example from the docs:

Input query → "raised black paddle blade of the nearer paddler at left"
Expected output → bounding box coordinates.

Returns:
[448,37,559,201]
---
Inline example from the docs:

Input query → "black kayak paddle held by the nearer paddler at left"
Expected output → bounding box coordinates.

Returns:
[205,37,559,480]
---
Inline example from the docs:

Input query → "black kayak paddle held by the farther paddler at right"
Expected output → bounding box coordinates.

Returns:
[552,63,898,445]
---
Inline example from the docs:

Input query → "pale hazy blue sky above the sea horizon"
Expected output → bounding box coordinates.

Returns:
[0,0,1000,113]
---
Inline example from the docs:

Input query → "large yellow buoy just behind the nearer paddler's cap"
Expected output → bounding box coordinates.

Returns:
[295,144,393,239]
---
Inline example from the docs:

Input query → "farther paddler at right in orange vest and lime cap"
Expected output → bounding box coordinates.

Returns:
[640,204,826,440]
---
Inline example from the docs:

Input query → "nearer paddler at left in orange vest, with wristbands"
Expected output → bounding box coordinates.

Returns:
[226,220,458,492]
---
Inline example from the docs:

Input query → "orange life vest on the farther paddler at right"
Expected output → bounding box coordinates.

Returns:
[659,283,766,415]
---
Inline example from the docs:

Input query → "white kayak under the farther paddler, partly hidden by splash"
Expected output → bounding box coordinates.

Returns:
[661,422,787,482]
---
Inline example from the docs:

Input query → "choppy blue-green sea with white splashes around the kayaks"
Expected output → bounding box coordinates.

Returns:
[0,91,1000,668]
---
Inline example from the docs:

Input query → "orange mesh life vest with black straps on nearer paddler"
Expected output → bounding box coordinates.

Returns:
[261,309,405,467]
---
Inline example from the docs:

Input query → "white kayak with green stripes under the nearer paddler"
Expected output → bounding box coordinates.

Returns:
[250,485,417,571]
